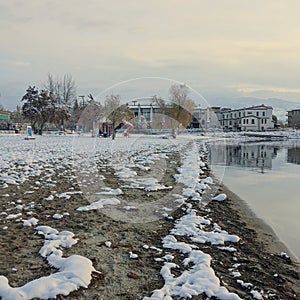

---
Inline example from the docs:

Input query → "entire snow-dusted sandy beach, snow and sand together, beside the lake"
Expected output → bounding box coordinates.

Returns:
[0,135,299,299]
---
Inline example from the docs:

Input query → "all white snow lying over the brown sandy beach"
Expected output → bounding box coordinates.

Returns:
[0,136,250,300]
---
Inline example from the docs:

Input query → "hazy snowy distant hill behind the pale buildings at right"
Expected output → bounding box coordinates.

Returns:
[209,97,300,122]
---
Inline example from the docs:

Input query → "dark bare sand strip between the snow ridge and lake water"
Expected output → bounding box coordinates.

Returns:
[205,180,300,299]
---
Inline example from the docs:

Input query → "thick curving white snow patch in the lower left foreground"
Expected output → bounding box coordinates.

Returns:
[0,226,97,300]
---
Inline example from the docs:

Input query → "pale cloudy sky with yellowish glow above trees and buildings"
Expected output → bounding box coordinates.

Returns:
[0,0,300,109]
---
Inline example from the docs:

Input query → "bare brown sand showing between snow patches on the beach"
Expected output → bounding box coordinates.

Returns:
[0,137,300,300]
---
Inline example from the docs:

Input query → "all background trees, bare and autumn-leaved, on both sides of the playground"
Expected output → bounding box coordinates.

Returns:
[7,74,195,137]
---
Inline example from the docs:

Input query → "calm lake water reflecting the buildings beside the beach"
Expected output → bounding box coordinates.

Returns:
[210,140,300,260]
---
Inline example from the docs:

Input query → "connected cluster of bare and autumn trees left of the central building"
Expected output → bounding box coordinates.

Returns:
[21,74,133,133]
